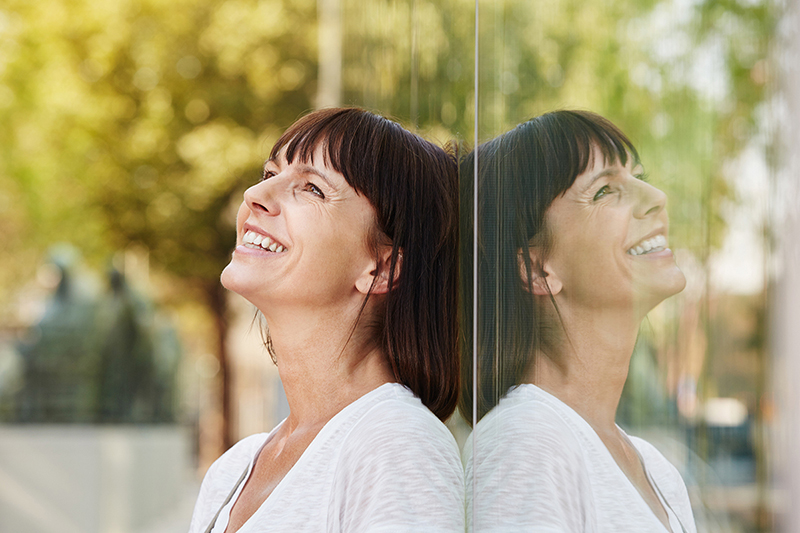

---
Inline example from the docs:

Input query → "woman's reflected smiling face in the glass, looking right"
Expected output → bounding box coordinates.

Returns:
[546,149,686,315]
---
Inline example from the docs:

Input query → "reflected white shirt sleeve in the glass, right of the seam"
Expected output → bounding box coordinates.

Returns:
[465,407,593,533]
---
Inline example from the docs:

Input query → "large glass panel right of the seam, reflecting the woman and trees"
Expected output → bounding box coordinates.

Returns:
[462,1,779,531]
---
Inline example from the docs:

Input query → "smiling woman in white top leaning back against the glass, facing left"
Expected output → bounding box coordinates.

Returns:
[190,109,464,533]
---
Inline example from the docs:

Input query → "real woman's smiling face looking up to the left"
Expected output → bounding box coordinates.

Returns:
[222,143,376,314]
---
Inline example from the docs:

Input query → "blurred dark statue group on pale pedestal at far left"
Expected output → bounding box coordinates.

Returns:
[0,250,181,423]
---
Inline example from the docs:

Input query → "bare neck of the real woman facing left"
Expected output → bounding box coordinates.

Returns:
[260,304,394,429]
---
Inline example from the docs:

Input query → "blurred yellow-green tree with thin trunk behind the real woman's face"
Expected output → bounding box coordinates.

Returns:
[0,0,316,443]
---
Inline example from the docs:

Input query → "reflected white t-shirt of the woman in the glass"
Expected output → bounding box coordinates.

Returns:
[463,385,696,533]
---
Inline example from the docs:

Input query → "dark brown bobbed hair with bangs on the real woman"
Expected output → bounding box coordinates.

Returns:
[270,108,459,420]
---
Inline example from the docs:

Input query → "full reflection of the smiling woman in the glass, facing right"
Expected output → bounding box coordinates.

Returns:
[461,111,695,533]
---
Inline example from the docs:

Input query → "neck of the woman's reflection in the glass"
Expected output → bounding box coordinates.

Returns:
[526,307,639,434]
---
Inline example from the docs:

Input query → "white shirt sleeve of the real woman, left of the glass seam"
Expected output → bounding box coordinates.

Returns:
[329,402,464,533]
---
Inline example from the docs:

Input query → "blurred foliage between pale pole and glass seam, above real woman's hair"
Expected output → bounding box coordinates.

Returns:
[342,0,474,137]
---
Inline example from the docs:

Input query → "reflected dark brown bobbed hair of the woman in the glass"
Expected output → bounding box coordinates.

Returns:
[459,111,639,422]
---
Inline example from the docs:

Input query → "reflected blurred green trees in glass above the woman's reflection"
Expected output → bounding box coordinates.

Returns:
[479,0,777,255]
